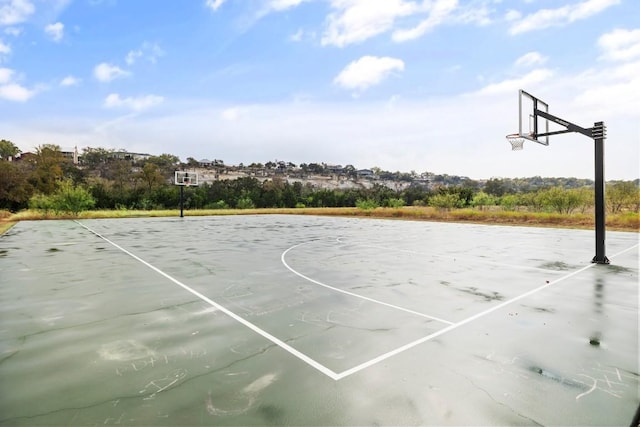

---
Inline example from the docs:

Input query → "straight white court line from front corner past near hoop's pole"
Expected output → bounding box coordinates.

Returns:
[337,244,639,380]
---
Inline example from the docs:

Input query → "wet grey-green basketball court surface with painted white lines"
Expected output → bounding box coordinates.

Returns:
[0,216,640,426]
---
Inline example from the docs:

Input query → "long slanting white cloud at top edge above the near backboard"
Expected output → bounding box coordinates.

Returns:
[509,0,620,35]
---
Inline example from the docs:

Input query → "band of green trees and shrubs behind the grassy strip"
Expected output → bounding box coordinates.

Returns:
[0,140,640,213]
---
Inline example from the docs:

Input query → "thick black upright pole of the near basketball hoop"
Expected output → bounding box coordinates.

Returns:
[591,122,609,264]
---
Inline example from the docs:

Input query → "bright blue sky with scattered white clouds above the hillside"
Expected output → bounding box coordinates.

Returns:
[0,0,640,180]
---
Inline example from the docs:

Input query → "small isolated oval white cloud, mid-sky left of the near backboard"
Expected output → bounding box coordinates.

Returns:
[333,56,404,90]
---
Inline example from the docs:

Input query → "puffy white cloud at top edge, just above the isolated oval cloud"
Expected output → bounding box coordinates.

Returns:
[321,0,419,47]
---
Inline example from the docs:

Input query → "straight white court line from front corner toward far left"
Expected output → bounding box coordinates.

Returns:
[74,221,339,381]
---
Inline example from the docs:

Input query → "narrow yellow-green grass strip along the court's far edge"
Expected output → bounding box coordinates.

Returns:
[0,207,640,233]
